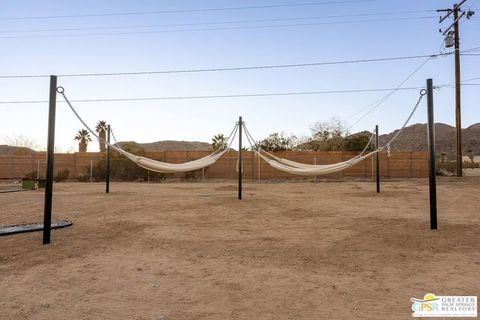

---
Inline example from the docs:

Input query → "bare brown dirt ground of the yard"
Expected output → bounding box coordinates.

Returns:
[0,176,480,320]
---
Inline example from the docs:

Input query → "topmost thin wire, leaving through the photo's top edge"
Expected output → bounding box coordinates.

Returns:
[0,0,376,20]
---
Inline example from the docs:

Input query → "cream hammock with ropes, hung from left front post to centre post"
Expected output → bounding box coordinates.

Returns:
[57,87,238,173]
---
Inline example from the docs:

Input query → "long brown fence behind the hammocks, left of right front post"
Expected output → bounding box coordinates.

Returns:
[0,151,428,180]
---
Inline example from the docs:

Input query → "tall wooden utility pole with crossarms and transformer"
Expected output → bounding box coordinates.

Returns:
[437,0,475,177]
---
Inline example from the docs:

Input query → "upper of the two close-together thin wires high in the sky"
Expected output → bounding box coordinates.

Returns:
[0,10,436,34]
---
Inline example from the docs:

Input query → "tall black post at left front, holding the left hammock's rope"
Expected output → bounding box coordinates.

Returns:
[43,76,57,244]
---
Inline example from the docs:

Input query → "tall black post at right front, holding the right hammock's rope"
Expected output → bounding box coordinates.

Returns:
[427,79,437,230]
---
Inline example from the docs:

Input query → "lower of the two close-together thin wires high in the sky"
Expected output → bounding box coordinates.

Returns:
[0,16,437,39]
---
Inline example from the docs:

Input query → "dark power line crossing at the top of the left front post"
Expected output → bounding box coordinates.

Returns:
[0,53,452,79]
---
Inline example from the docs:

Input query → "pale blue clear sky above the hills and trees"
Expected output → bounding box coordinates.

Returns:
[0,0,480,152]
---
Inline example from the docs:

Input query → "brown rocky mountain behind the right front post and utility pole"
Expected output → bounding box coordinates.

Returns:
[379,123,480,159]
